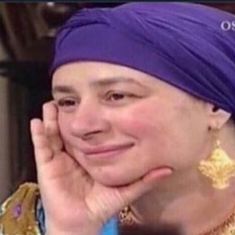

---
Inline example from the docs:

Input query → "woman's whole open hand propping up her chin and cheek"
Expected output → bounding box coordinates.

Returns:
[31,102,171,235]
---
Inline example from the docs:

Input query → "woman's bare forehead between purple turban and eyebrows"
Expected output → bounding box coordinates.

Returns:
[52,62,160,86]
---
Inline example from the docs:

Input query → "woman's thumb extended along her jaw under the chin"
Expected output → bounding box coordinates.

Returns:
[121,167,173,206]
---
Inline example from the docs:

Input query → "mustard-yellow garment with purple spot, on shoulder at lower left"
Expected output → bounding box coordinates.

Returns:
[0,183,41,235]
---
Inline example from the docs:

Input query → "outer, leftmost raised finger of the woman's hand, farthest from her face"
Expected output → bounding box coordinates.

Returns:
[30,119,53,167]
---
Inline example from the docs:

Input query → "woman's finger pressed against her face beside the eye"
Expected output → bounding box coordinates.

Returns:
[43,101,63,153]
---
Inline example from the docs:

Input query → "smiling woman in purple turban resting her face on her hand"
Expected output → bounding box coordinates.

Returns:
[1,3,235,235]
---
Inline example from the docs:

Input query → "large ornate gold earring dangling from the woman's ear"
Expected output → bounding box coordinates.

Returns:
[198,129,235,189]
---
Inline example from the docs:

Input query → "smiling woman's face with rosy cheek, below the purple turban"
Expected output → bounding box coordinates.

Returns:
[53,62,208,186]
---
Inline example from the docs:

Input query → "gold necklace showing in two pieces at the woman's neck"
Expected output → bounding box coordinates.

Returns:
[118,206,235,235]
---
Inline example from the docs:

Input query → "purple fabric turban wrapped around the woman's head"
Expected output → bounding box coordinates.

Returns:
[51,2,235,114]
